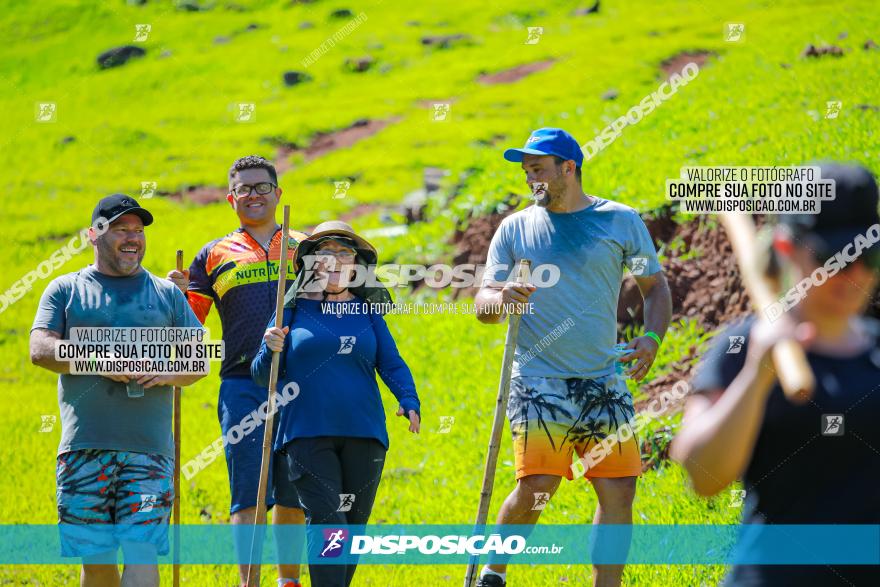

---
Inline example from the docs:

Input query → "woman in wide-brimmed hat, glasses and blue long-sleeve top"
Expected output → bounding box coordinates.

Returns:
[251,221,420,587]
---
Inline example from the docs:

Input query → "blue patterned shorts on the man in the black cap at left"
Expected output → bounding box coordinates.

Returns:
[55,449,174,564]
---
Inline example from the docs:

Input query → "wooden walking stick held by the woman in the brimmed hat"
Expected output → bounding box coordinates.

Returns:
[246,206,290,587]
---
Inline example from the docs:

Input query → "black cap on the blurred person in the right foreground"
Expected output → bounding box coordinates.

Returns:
[779,163,880,259]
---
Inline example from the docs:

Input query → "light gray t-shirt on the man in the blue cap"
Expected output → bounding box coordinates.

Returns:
[483,198,660,378]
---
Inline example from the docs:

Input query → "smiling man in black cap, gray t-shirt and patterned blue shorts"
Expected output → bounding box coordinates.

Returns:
[30,194,203,586]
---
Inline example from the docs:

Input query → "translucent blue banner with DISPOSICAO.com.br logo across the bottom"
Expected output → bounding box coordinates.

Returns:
[0,524,880,565]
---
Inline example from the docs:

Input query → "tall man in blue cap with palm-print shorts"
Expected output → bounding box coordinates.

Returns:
[476,128,672,587]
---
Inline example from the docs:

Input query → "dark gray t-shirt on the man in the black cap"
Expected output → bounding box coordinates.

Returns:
[33,265,201,458]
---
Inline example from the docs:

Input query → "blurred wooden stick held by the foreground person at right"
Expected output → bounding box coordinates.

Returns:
[718,214,816,404]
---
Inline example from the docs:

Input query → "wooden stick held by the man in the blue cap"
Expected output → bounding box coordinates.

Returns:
[464,259,531,587]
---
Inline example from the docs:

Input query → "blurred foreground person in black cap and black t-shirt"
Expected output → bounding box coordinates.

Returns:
[671,164,880,587]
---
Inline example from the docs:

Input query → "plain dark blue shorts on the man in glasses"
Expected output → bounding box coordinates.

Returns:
[217,377,300,514]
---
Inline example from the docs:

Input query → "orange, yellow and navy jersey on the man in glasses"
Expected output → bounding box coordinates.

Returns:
[186,228,306,379]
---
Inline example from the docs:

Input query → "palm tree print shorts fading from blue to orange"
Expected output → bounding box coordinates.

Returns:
[507,373,642,479]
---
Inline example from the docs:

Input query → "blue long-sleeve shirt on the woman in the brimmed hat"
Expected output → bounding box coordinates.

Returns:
[251,298,420,450]
